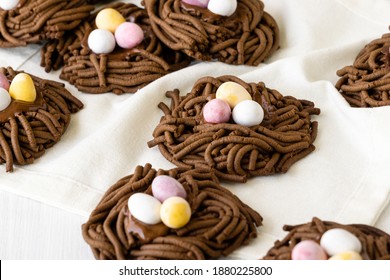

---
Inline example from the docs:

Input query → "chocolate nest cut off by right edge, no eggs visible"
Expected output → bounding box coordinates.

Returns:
[336,27,390,107]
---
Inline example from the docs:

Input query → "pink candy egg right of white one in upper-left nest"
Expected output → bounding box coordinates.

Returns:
[115,22,144,49]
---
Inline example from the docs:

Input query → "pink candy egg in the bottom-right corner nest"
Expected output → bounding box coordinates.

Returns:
[291,240,328,260]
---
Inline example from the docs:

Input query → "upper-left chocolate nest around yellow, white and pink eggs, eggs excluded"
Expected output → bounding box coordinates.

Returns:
[41,2,191,94]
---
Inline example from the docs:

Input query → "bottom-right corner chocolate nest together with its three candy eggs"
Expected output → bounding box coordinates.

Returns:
[263,218,390,260]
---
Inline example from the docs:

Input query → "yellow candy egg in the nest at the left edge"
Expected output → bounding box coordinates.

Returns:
[9,73,37,102]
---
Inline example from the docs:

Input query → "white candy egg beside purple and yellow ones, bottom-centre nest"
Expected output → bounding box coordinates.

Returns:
[127,193,161,225]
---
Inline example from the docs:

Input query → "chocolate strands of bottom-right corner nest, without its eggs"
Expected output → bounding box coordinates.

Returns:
[264,218,390,260]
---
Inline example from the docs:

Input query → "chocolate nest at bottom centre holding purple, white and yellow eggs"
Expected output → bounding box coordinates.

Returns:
[82,164,262,259]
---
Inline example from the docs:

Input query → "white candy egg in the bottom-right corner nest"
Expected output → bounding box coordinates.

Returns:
[320,228,362,256]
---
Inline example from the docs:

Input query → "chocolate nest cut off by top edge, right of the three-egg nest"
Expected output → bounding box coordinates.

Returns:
[143,0,279,66]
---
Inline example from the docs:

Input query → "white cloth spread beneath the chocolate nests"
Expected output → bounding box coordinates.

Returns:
[0,0,390,259]
